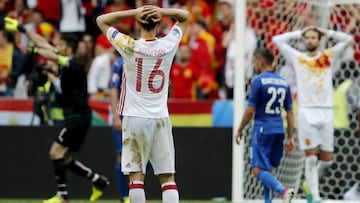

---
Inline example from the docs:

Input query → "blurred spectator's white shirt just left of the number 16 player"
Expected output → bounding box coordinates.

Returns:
[87,52,112,94]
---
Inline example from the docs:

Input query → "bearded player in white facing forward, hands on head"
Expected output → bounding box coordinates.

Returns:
[272,26,353,203]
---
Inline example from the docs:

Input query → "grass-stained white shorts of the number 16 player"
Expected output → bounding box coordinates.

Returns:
[121,116,175,175]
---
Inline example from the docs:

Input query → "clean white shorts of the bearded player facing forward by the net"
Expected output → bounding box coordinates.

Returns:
[297,108,334,152]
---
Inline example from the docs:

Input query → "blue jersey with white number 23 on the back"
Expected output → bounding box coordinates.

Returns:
[248,71,293,134]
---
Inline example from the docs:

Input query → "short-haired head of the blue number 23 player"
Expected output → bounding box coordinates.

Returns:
[253,48,275,73]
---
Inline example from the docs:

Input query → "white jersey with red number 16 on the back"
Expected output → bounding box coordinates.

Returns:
[107,25,183,118]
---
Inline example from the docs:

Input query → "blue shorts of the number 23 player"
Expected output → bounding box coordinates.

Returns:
[251,131,284,171]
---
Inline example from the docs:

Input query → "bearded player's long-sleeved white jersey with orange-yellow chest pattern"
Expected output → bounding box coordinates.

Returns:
[273,31,352,108]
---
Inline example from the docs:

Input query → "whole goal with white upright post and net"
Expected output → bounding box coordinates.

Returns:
[231,0,360,203]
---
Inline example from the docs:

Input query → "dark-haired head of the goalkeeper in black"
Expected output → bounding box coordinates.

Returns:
[57,34,79,56]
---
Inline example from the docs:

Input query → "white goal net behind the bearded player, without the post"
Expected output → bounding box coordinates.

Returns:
[243,0,360,200]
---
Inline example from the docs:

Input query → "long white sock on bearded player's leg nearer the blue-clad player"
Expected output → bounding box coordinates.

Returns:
[305,156,320,201]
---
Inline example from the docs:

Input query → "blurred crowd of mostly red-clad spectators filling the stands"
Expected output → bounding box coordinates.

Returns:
[0,0,360,100]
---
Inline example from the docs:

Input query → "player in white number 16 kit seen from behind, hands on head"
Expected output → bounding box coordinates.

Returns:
[96,5,189,203]
